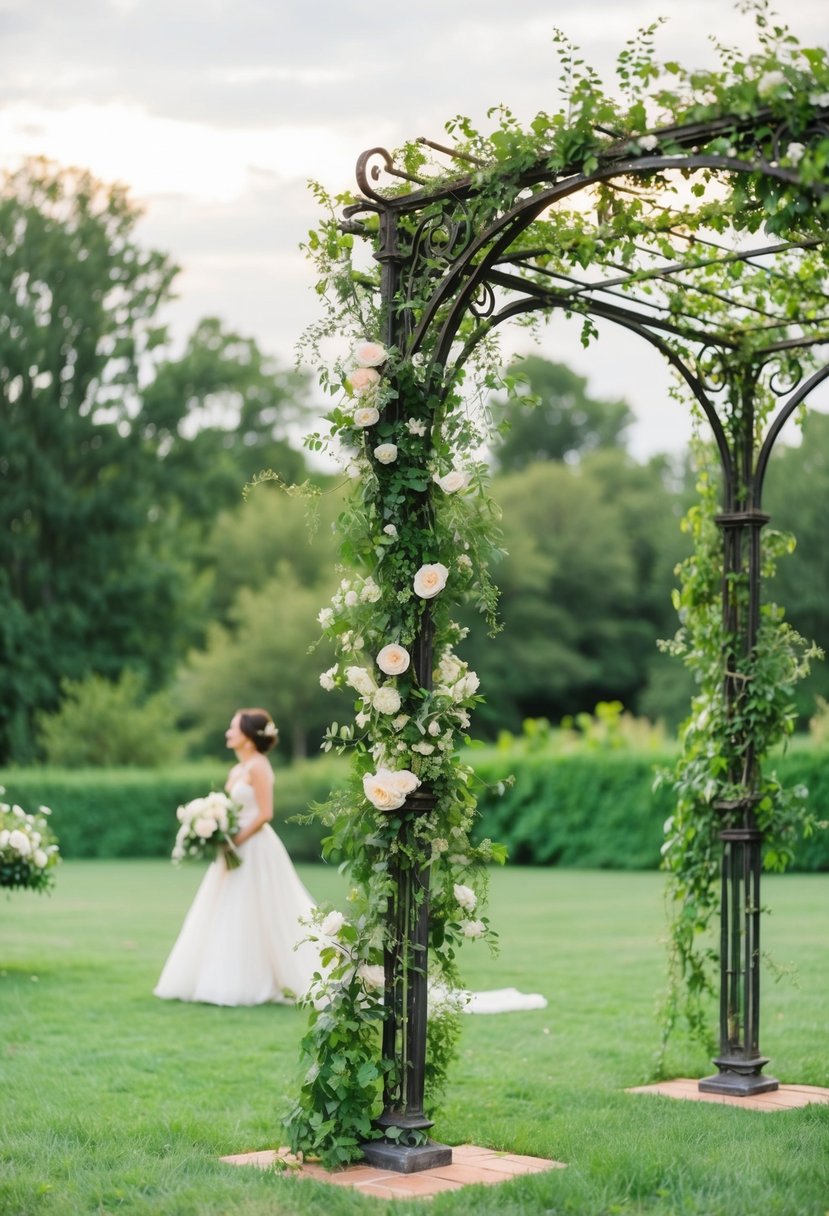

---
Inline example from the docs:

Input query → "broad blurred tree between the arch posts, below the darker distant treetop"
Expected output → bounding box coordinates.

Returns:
[454,451,683,732]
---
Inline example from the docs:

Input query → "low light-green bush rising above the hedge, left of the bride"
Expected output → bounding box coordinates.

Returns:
[36,671,186,769]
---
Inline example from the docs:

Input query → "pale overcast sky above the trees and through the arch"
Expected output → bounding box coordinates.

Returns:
[0,0,829,456]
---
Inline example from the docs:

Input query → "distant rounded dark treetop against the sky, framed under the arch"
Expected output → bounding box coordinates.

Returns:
[492,355,633,473]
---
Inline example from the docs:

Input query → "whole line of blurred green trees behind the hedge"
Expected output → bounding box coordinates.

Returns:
[0,161,829,764]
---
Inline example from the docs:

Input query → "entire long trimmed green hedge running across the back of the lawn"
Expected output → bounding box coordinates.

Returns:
[0,745,829,871]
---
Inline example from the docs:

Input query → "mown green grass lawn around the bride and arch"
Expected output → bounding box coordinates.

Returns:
[0,861,829,1216]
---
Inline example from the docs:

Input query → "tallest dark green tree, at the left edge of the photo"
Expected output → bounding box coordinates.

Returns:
[0,161,190,760]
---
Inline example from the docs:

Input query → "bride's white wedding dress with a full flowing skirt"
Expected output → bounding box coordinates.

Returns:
[153,778,320,1006]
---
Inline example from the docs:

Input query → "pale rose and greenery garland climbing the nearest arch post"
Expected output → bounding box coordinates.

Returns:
[287,340,506,1165]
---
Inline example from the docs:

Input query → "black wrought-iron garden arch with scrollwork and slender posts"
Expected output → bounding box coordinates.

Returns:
[352,107,829,1167]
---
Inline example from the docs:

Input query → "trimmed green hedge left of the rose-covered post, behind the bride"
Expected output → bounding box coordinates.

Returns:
[0,759,345,861]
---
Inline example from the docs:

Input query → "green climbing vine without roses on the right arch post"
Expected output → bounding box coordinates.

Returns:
[659,457,820,1055]
